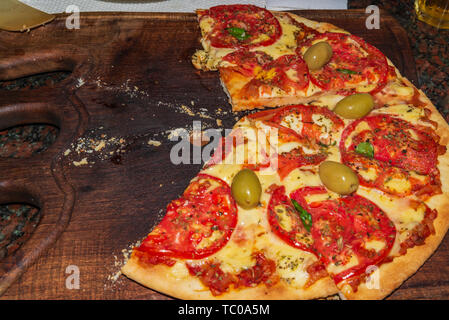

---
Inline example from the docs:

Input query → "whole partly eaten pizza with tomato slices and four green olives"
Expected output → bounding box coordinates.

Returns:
[122,5,449,299]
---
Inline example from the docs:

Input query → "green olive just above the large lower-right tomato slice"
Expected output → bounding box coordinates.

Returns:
[319,161,359,194]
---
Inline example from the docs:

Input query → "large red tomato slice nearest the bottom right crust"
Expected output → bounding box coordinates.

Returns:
[290,187,396,284]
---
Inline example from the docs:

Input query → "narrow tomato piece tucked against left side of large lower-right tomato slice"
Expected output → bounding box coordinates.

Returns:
[267,186,313,252]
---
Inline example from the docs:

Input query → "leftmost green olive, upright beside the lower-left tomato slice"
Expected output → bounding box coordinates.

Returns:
[231,169,262,209]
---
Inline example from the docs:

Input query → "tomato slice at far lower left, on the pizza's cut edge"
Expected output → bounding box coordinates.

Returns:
[136,174,237,263]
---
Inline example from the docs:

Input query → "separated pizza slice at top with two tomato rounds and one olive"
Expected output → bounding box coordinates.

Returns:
[192,5,394,111]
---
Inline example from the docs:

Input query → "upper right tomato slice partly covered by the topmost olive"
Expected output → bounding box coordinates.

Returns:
[297,32,389,94]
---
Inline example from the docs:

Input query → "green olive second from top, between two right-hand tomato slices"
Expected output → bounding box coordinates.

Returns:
[334,93,374,119]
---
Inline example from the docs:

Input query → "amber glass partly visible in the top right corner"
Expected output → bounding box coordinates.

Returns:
[415,0,449,29]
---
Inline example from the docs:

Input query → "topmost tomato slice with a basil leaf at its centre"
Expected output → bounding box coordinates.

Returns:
[200,4,282,48]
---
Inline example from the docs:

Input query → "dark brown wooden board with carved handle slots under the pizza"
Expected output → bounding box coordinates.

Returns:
[0,10,442,299]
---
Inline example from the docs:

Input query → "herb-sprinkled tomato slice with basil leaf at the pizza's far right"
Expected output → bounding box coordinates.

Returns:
[340,115,446,195]
